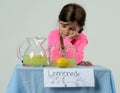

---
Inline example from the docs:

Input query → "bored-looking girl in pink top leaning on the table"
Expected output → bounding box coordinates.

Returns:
[48,3,92,66]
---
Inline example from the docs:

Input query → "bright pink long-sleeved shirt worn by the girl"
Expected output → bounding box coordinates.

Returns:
[48,29,88,64]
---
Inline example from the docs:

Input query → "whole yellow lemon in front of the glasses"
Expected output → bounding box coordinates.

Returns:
[56,57,69,68]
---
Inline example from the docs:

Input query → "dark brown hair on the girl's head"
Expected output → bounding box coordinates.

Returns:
[59,3,86,33]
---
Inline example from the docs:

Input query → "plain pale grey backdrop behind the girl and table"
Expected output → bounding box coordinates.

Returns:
[0,0,120,93]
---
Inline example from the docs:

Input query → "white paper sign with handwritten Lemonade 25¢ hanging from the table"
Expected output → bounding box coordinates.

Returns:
[44,68,94,87]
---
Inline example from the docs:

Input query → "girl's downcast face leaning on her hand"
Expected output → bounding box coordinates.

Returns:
[59,21,82,38]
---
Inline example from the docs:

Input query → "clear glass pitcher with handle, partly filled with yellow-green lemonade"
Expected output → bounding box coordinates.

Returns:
[17,37,47,66]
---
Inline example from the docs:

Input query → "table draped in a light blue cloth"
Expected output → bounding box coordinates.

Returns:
[6,64,116,93]
